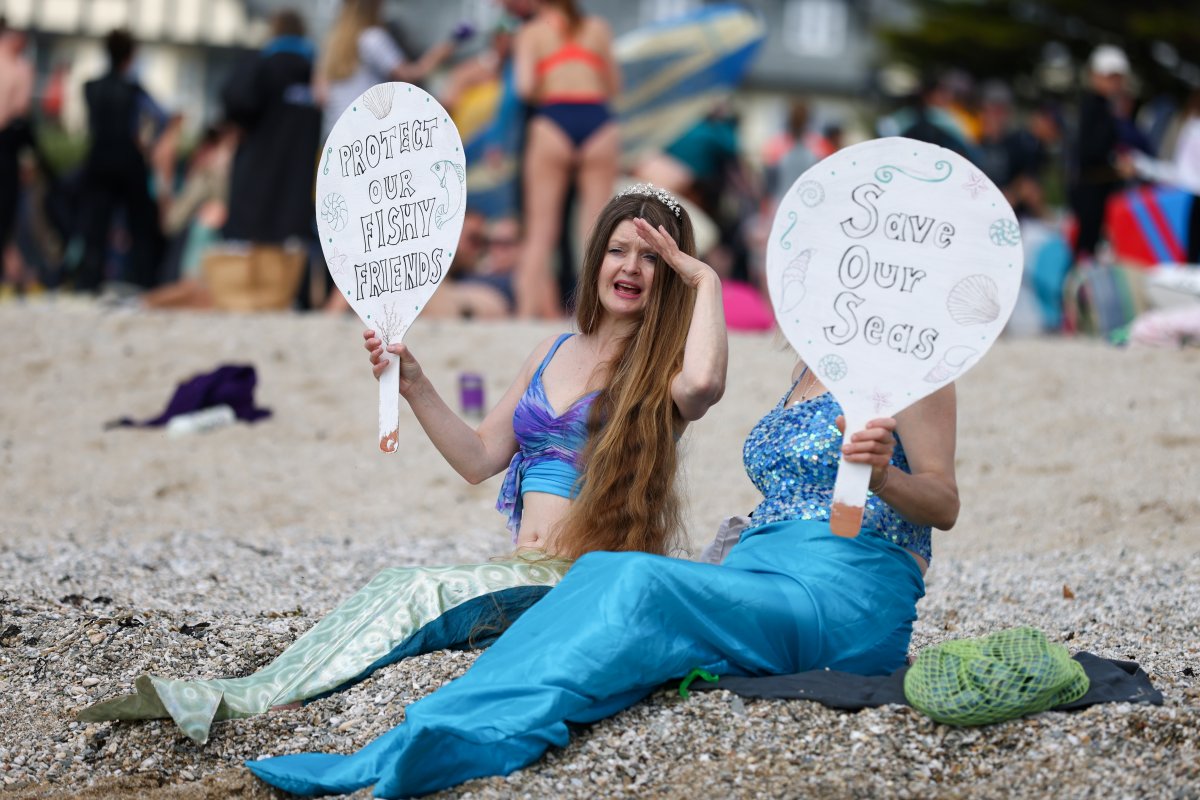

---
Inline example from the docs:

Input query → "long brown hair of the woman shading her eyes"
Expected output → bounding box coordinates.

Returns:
[554,194,696,558]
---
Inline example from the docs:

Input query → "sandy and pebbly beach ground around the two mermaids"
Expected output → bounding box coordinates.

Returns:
[0,300,1200,800]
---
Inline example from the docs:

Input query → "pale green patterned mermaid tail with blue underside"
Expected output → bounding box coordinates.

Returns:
[78,557,570,745]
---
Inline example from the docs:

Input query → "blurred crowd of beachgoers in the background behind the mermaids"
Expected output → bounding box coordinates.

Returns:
[0,0,1200,333]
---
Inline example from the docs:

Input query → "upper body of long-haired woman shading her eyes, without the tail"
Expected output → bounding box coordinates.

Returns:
[381,186,726,558]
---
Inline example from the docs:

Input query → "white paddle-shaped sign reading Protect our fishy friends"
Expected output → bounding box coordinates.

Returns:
[316,83,467,452]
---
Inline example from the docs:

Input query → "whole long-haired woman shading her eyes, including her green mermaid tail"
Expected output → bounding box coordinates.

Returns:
[80,186,727,742]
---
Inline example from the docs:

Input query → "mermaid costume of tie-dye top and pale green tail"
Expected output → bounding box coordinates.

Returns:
[79,333,595,744]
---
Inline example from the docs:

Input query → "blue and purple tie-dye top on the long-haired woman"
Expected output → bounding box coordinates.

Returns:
[496,333,599,543]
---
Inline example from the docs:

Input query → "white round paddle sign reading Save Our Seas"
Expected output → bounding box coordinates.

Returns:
[767,138,1022,536]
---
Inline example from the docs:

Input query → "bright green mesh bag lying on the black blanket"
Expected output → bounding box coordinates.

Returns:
[904,627,1087,726]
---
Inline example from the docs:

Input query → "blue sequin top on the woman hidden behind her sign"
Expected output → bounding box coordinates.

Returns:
[742,381,931,561]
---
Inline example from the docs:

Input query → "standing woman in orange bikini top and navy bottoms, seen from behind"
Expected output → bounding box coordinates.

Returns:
[514,0,620,318]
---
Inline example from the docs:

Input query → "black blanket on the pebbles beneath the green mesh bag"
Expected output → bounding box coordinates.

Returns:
[689,652,1163,711]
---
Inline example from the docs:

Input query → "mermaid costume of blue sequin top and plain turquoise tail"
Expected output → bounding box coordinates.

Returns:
[246,385,930,798]
